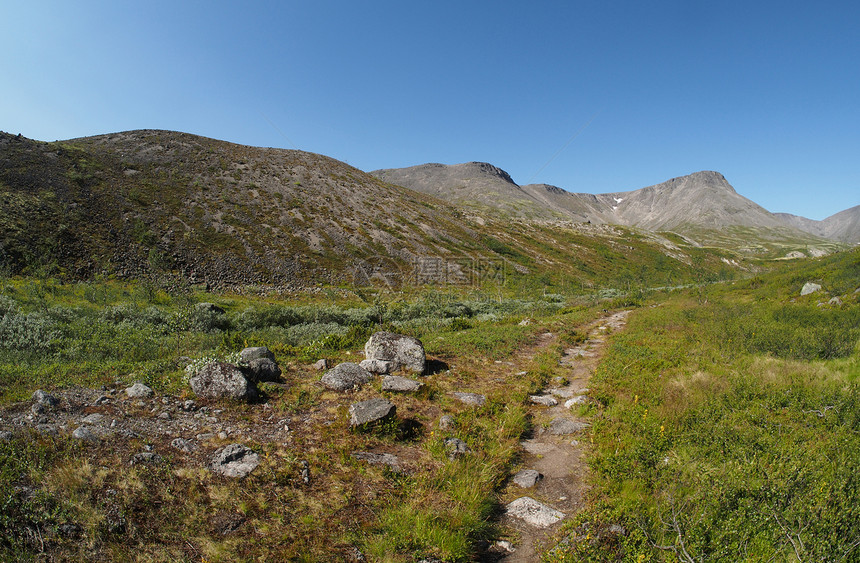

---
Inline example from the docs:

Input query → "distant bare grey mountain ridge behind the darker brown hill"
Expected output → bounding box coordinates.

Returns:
[371,162,860,243]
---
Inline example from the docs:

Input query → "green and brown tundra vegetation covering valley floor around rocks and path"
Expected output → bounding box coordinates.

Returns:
[0,250,860,562]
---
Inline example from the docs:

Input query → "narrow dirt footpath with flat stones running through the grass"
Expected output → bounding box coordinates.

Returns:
[497,311,629,563]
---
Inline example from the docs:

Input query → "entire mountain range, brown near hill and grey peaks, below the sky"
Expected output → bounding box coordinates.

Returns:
[0,130,858,290]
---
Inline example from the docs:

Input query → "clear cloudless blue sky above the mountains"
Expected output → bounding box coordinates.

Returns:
[0,0,860,219]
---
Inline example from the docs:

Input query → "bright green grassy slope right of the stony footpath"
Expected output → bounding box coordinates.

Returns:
[545,251,860,561]
